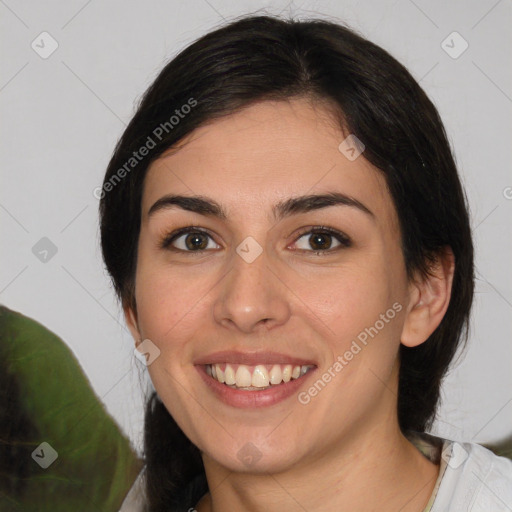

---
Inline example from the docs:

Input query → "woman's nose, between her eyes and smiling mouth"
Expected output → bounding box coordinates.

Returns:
[213,246,290,334]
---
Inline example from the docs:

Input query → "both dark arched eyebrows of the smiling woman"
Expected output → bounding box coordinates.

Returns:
[148,192,375,221]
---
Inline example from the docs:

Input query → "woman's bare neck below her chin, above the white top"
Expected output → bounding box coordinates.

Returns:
[196,418,439,512]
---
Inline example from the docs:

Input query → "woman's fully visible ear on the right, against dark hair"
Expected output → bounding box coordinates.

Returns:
[401,247,455,347]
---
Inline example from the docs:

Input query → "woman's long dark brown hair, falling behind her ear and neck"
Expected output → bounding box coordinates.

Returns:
[100,16,474,511]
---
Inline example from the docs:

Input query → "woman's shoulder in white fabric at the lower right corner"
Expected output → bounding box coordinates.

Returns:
[431,439,512,512]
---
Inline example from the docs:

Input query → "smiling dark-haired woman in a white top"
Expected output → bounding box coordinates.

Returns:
[100,16,512,512]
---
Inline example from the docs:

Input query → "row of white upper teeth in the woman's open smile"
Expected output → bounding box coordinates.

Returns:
[206,363,313,388]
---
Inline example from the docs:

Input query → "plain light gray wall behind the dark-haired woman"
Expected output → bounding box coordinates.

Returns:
[0,0,512,456]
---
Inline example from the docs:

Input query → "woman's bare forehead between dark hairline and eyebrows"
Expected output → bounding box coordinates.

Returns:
[142,99,394,226]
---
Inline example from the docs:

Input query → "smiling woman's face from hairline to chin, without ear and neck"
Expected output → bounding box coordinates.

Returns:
[128,99,409,471]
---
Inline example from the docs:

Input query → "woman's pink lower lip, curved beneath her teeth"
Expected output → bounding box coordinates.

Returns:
[196,365,316,408]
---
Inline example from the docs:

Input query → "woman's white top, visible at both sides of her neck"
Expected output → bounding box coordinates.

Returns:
[119,434,512,512]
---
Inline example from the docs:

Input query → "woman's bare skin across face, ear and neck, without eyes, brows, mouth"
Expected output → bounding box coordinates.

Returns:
[125,98,453,512]
